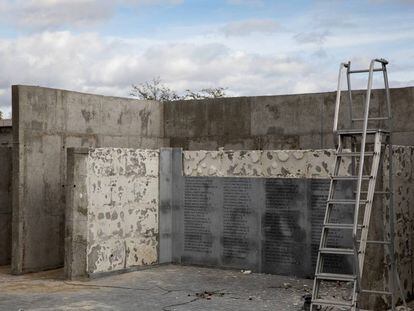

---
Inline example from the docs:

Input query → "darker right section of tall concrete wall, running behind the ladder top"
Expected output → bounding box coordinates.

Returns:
[164,87,414,150]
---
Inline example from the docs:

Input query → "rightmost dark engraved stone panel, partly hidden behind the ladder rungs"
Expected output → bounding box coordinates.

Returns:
[310,179,353,273]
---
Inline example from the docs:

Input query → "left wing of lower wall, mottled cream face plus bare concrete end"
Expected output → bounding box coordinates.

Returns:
[65,148,159,278]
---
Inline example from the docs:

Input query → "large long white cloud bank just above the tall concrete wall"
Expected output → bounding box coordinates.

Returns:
[0,31,309,117]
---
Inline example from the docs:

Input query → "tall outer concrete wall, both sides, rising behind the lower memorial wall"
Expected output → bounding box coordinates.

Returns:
[6,86,414,273]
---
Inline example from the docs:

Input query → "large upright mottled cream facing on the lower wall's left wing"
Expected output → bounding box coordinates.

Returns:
[87,148,159,274]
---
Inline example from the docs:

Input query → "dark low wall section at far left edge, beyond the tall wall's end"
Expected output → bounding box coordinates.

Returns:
[0,147,12,266]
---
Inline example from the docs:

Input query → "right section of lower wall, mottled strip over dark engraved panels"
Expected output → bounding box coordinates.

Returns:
[160,149,353,277]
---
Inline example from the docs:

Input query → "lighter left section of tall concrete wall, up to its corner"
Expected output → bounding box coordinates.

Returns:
[12,86,165,273]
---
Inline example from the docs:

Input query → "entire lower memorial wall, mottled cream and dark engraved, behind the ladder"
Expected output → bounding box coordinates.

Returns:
[66,146,414,296]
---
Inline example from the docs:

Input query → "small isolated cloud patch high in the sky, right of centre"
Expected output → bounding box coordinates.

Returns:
[221,19,282,37]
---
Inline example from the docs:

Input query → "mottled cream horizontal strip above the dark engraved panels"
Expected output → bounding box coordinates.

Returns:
[183,149,351,178]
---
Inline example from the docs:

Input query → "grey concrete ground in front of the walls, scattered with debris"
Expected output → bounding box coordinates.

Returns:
[0,265,410,311]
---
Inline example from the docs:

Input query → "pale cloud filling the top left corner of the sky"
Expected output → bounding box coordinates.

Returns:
[0,0,183,31]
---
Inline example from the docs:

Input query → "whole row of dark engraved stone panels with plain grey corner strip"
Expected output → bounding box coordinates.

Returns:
[160,149,353,277]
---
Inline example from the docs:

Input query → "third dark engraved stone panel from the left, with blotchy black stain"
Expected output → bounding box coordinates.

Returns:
[262,179,310,276]
